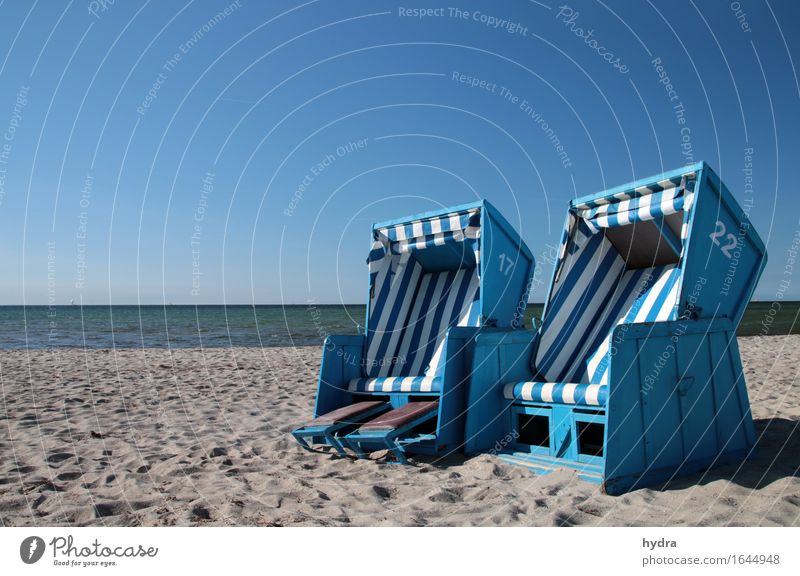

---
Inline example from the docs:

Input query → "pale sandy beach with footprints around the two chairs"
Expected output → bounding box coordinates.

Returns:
[0,336,800,526]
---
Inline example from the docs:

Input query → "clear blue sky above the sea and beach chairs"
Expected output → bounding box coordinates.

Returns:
[0,0,800,304]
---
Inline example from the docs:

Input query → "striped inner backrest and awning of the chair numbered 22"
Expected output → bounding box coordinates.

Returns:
[532,173,694,384]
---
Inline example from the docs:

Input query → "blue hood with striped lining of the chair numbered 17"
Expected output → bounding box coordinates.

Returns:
[364,202,533,378]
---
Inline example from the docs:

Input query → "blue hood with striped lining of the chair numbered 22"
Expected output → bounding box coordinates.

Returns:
[532,163,764,384]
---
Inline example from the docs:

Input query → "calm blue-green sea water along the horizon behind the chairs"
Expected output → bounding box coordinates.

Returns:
[0,302,800,348]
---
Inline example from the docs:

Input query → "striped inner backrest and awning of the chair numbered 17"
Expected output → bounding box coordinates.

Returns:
[364,208,481,377]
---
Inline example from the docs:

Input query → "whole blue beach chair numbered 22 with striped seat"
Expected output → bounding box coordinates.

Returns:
[465,163,766,494]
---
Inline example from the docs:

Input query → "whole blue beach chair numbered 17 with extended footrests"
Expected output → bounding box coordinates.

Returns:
[293,201,533,462]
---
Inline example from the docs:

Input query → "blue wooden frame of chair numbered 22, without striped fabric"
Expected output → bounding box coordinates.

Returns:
[465,162,767,494]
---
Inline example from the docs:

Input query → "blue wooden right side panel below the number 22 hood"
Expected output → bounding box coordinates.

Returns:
[603,318,756,494]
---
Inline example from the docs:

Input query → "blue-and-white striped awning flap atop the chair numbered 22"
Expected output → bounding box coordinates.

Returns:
[574,174,694,233]
